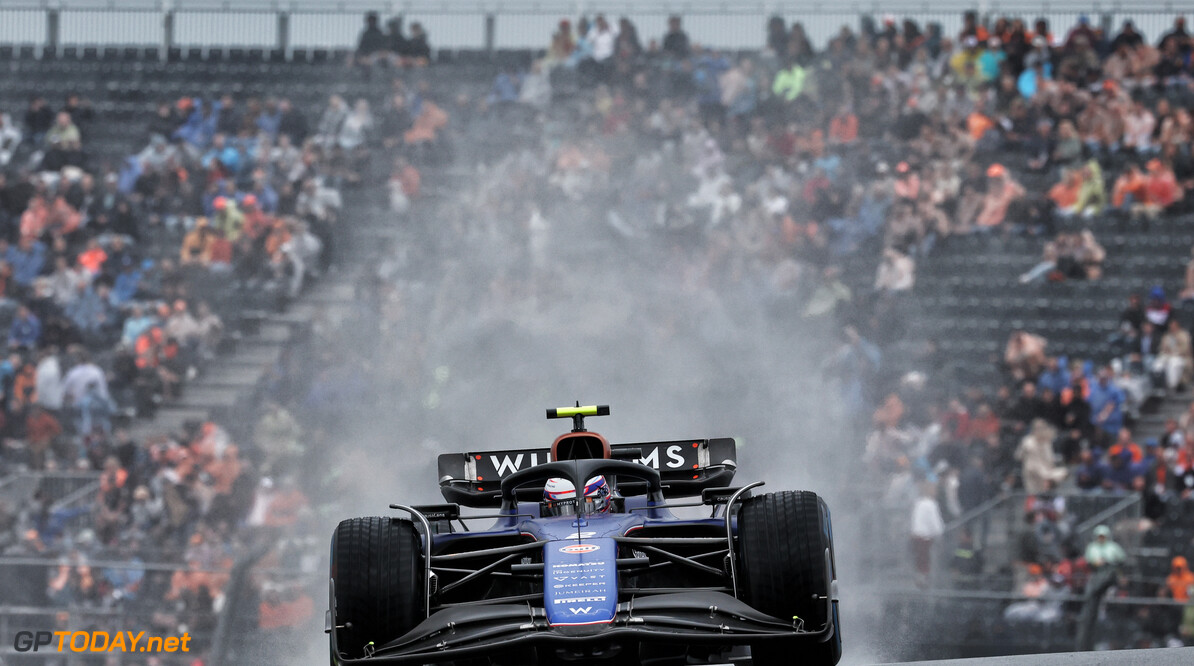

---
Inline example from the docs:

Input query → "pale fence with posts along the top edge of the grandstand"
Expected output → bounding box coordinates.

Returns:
[0,0,1180,57]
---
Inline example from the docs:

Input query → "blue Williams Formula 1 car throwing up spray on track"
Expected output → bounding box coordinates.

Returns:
[326,405,842,666]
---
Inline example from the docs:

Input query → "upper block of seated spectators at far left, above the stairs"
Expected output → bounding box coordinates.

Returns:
[0,81,358,477]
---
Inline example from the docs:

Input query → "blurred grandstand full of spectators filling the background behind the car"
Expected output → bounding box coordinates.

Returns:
[0,2,1194,664]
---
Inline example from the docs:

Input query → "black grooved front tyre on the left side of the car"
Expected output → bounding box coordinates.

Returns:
[331,517,426,659]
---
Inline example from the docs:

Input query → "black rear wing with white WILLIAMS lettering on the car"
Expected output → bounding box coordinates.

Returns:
[439,437,738,507]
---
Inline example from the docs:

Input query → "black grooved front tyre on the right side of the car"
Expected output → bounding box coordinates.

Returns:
[737,491,842,666]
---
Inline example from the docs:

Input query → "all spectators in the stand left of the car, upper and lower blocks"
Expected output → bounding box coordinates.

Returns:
[0,42,429,666]
